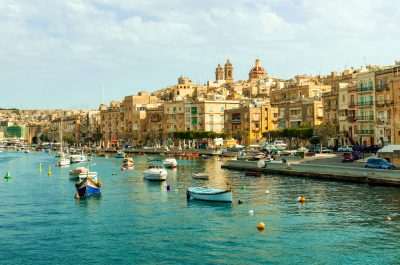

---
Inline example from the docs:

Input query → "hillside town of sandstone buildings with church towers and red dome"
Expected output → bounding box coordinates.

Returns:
[0,59,400,148]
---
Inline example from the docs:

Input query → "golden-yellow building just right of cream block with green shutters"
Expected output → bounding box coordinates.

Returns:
[224,101,279,145]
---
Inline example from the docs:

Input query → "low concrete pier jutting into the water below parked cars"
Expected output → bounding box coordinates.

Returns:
[221,160,400,187]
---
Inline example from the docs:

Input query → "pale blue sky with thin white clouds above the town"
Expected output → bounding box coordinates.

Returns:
[0,0,400,109]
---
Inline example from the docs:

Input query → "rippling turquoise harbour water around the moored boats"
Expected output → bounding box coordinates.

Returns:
[0,152,400,264]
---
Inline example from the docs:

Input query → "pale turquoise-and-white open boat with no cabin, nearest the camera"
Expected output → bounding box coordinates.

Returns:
[186,187,232,202]
